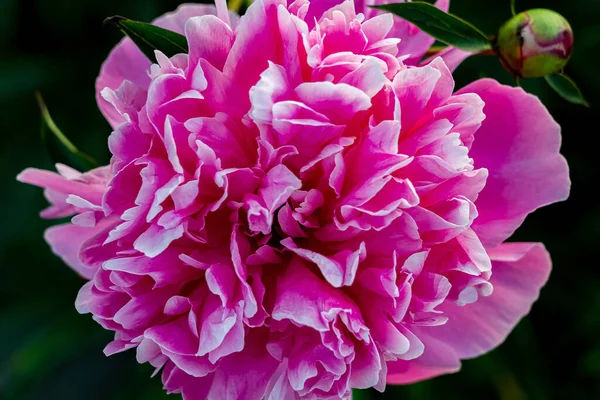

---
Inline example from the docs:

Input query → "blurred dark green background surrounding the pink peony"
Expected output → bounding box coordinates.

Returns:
[0,0,600,400]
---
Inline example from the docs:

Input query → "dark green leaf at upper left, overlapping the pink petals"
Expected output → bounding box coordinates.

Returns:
[104,15,188,61]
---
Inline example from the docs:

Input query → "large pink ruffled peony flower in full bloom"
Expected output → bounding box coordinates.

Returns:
[18,0,569,399]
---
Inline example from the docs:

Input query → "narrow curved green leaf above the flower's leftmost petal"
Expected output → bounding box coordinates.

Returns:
[35,93,98,171]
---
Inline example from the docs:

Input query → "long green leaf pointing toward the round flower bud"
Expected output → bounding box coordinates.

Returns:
[372,1,493,52]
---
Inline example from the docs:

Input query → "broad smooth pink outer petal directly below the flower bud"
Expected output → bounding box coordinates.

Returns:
[459,79,570,248]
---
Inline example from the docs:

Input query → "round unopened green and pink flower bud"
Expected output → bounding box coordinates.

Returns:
[496,8,573,78]
